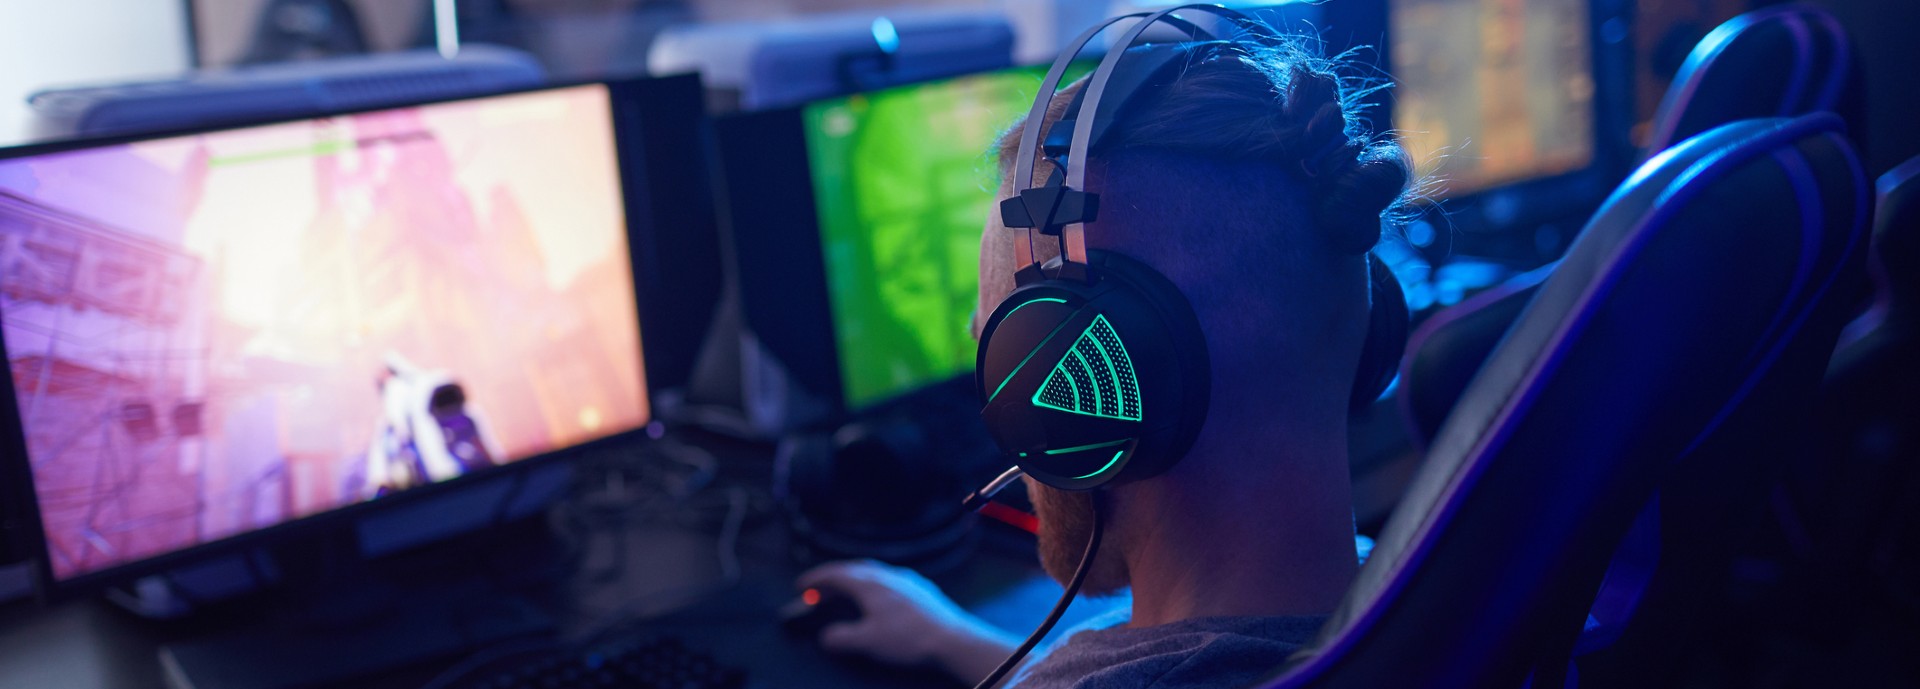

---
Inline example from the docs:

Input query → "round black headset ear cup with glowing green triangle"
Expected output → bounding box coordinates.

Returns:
[975,249,1212,491]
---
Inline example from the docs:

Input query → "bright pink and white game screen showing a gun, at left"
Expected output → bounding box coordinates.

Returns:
[0,86,649,580]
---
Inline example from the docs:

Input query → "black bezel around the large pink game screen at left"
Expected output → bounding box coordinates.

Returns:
[0,75,699,603]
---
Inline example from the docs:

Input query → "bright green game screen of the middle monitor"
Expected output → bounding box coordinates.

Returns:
[803,67,1085,407]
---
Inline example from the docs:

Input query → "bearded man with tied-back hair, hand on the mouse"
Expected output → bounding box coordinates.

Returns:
[799,35,1409,689]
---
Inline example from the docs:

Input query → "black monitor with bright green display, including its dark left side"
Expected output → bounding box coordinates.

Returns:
[716,67,1085,416]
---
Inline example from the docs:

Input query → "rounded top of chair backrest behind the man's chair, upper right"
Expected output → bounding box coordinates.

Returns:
[1642,4,1866,159]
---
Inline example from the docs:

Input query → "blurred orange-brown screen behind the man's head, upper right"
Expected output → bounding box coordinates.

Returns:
[1390,0,1597,198]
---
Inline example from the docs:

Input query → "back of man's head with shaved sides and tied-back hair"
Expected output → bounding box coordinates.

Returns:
[985,38,1409,424]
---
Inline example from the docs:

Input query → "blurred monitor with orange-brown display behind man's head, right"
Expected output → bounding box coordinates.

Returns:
[1373,0,1634,269]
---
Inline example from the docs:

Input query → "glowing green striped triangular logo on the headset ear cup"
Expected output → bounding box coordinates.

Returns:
[1033,315,1140,420]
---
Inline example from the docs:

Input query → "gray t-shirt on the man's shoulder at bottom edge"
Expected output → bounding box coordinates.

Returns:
[1012,616,1327,689]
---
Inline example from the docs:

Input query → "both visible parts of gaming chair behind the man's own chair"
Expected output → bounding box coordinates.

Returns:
[1400,4,1866,443]
